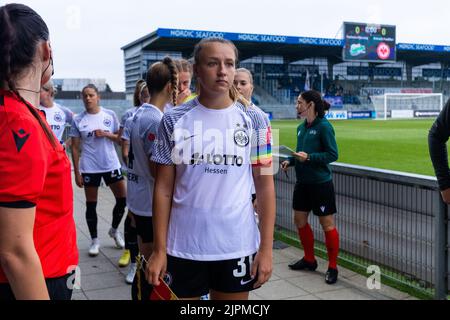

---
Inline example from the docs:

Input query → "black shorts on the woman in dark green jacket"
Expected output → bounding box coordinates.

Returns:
[292,181,337,217]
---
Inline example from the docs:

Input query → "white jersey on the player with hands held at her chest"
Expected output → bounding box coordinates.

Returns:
[70,108,121,173]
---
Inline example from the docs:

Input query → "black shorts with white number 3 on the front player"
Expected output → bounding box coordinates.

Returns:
[165,253,258,298]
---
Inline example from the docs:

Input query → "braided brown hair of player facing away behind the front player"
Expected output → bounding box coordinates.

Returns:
[146,57,178,106]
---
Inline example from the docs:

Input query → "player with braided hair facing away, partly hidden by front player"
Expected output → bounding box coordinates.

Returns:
[125,57,178,300]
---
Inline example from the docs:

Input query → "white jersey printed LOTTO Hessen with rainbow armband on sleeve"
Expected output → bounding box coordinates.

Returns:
[152,99,271,261]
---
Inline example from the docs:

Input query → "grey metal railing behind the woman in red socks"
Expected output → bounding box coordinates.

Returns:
[275,163,449,299]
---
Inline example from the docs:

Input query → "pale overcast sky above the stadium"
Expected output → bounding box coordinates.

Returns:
[6,0,450,91]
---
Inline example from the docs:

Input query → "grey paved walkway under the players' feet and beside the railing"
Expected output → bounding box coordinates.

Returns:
[73,184,415,300]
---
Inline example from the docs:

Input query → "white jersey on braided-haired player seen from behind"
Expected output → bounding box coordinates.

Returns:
[124,104,163,217]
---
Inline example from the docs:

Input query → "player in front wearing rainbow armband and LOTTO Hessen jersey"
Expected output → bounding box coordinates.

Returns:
[147,38,275,300]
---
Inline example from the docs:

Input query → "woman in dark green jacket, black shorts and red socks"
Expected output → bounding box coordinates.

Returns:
[281,90,339,284]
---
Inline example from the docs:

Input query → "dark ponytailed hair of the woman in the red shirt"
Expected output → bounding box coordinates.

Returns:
[0,3,57,147]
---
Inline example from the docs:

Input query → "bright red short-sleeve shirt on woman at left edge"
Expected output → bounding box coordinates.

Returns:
[0,90,78,283]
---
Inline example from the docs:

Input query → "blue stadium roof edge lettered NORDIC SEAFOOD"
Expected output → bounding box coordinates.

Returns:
[122,28,450,66]
